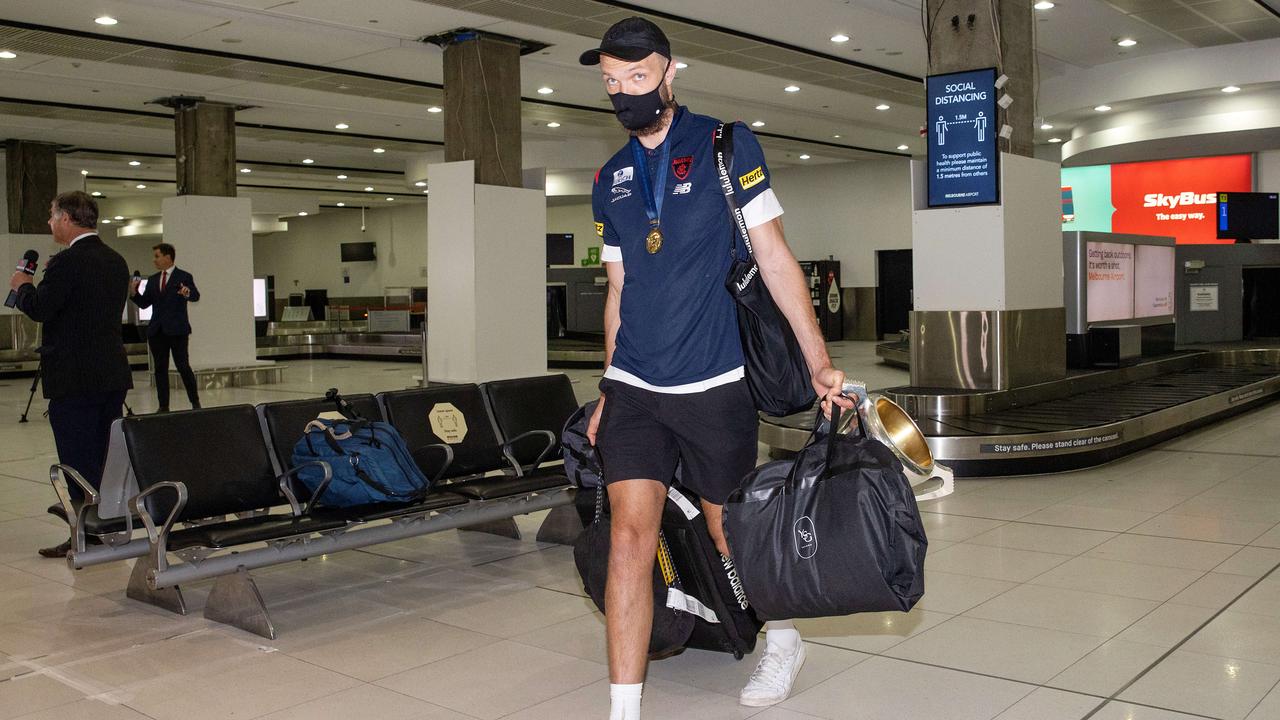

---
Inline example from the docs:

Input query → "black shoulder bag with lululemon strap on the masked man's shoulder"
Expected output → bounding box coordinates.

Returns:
[713,123,817,418]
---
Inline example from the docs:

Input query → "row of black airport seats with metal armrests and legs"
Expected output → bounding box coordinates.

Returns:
[50,375,581,638]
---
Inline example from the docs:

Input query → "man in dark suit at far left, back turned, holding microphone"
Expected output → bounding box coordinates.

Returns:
[9,191,133,557]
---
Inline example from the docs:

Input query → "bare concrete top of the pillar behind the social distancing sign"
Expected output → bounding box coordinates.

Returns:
[927,0,1036,158]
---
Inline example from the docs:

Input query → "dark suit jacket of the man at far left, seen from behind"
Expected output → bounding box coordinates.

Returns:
[17,234,133,400]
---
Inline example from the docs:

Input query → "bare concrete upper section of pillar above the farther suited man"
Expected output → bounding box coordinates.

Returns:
[161,97,237,197]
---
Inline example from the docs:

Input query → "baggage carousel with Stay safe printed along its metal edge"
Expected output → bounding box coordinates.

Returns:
[760,348,1280,477]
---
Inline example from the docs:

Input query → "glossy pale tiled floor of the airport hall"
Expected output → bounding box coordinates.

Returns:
[0,342,1280,720]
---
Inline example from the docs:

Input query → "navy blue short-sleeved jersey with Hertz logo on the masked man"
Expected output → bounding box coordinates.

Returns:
[591,108,782,392]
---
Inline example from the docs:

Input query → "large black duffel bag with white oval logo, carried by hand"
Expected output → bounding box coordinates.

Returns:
[724,404,928,620]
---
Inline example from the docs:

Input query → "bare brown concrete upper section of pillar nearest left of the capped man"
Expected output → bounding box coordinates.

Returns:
[433,32,521,185]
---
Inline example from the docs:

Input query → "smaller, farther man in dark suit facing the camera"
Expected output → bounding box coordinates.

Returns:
[129,242,200,413]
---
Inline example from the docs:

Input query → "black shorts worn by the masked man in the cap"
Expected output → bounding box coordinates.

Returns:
[595,379,760,505]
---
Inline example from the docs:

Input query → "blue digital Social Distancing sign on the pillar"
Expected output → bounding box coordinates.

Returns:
[925,68,1000,208]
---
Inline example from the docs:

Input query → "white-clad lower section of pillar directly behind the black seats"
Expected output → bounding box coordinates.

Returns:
[426,161,547,383]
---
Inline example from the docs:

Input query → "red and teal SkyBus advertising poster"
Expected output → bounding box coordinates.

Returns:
[1062,155,1253,245]
